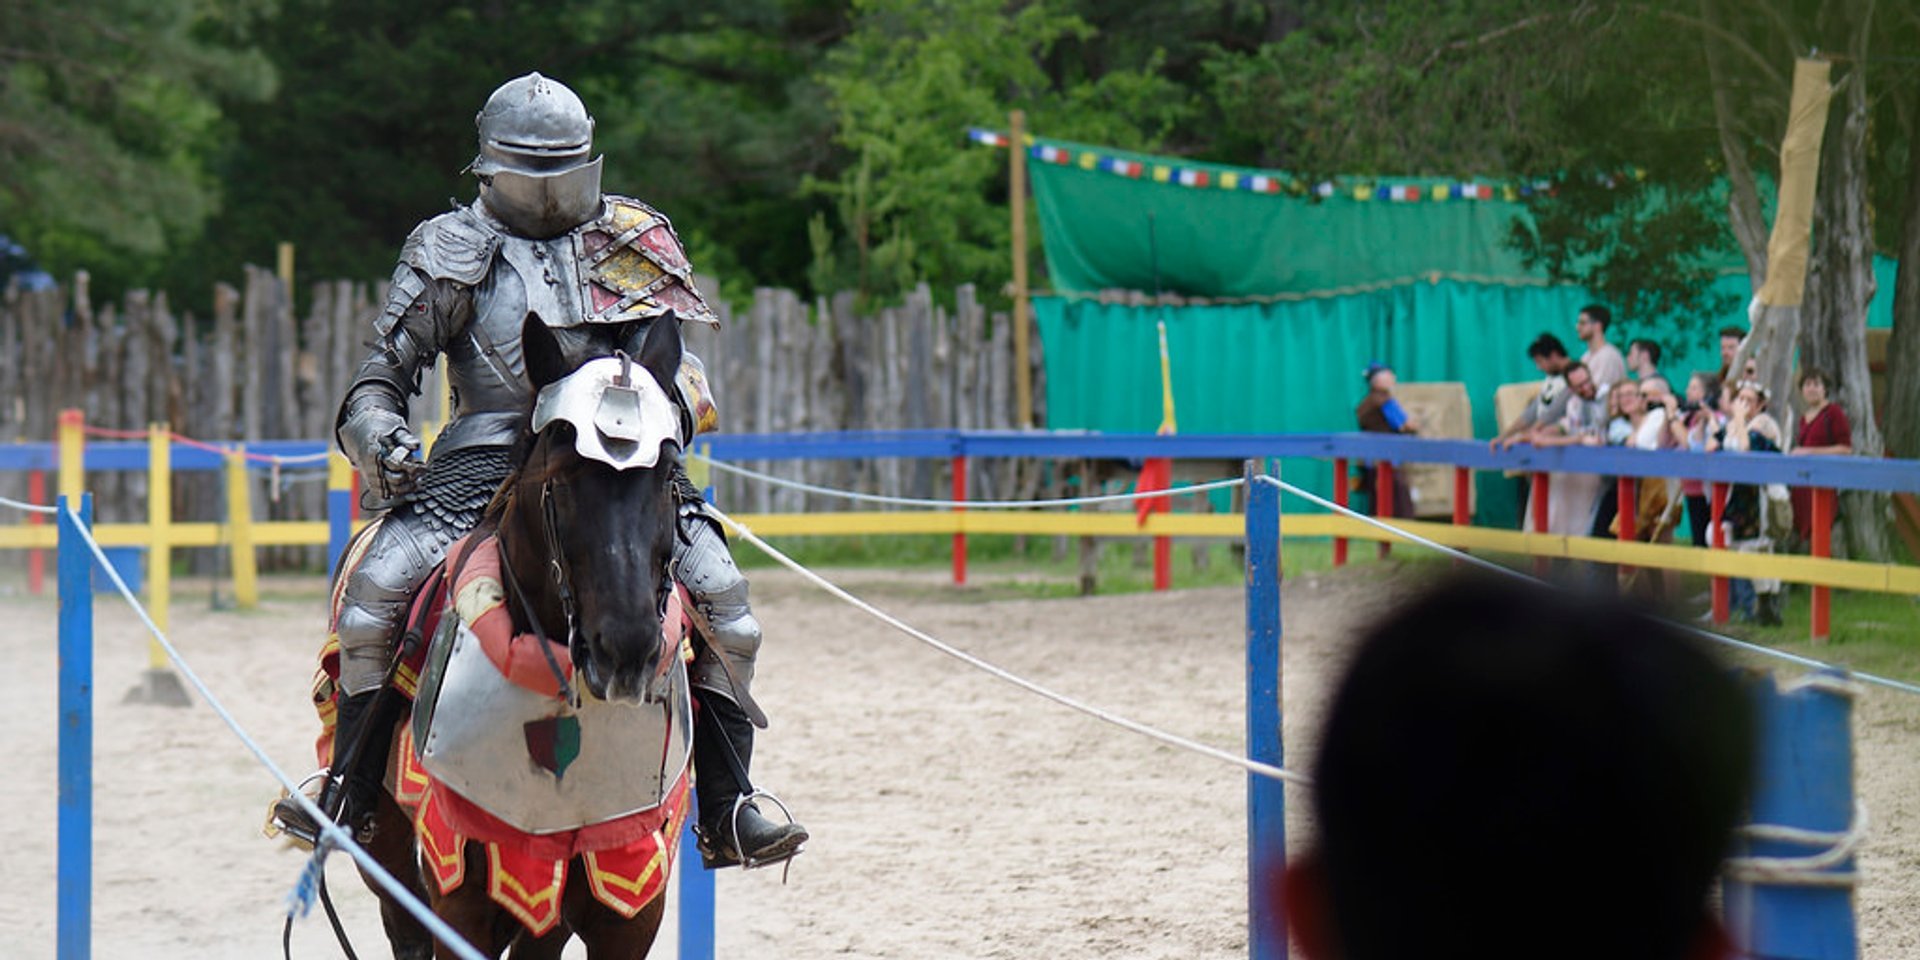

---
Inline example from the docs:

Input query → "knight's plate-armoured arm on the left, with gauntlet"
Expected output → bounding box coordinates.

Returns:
[334,209,499,499]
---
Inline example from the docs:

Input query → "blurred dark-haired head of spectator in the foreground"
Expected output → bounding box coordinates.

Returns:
[1284,580,1753,960]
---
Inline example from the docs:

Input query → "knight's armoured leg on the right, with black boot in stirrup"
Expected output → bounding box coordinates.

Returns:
[676,507,806,868]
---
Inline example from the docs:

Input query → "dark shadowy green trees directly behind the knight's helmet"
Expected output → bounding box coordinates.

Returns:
[171,0,845,307]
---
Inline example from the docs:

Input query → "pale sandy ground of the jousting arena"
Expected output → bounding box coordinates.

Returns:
[0,566,1920,960]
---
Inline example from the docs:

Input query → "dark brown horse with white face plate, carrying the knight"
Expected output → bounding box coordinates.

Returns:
[357,317,685,960]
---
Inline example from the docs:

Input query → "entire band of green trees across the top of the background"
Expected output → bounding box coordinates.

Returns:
[0,0,1920,330]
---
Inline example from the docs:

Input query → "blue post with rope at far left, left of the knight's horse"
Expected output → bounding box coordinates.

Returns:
[56,493,94,960]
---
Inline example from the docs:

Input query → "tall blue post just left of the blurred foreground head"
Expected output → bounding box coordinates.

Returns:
[1246,461,1286,960]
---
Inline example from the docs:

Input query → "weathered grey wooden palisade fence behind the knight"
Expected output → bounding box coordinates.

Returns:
[0,267,1039,568]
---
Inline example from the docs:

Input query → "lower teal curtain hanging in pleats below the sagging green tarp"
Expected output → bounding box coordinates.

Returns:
[1033,261,1893,522]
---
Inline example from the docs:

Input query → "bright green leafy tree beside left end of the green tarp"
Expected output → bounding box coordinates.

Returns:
[810,0,1188,296]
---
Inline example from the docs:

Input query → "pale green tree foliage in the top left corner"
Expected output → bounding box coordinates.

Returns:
[0,0,275,290]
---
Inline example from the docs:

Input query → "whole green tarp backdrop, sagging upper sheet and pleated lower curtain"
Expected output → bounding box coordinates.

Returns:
[1029,140,1895,522]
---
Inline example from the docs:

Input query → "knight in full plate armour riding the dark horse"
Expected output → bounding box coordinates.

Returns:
[282,73,806,868]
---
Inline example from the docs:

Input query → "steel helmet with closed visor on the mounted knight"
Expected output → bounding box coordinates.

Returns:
[468,73,601,238]
